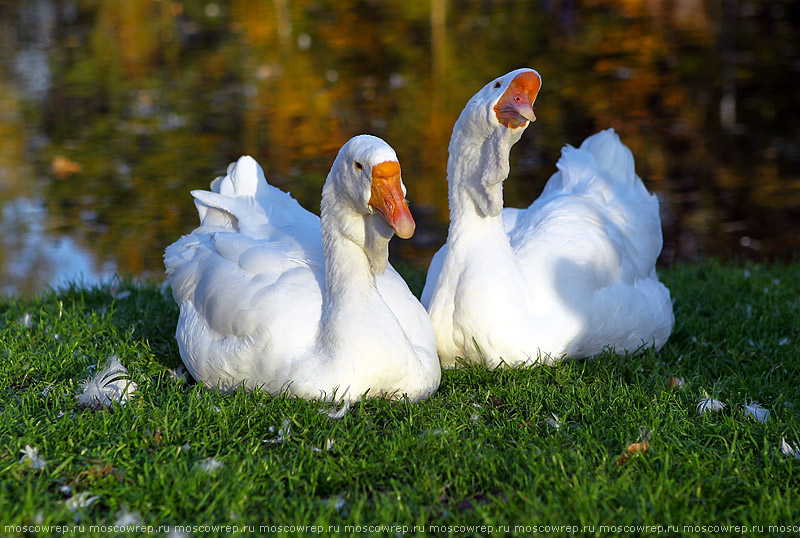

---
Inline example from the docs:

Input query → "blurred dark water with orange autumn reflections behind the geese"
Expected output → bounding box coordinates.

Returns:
[0,0,800,294]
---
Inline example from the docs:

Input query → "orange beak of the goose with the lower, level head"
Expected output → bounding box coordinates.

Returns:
[369,161,417,239]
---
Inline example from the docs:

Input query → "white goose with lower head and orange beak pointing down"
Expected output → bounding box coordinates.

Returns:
[164,135,441,401]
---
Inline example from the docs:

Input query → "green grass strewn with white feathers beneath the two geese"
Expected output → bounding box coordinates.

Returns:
[0,262,800,536]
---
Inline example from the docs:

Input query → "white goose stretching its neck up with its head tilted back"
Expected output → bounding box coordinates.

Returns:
[422,69,674,367]
